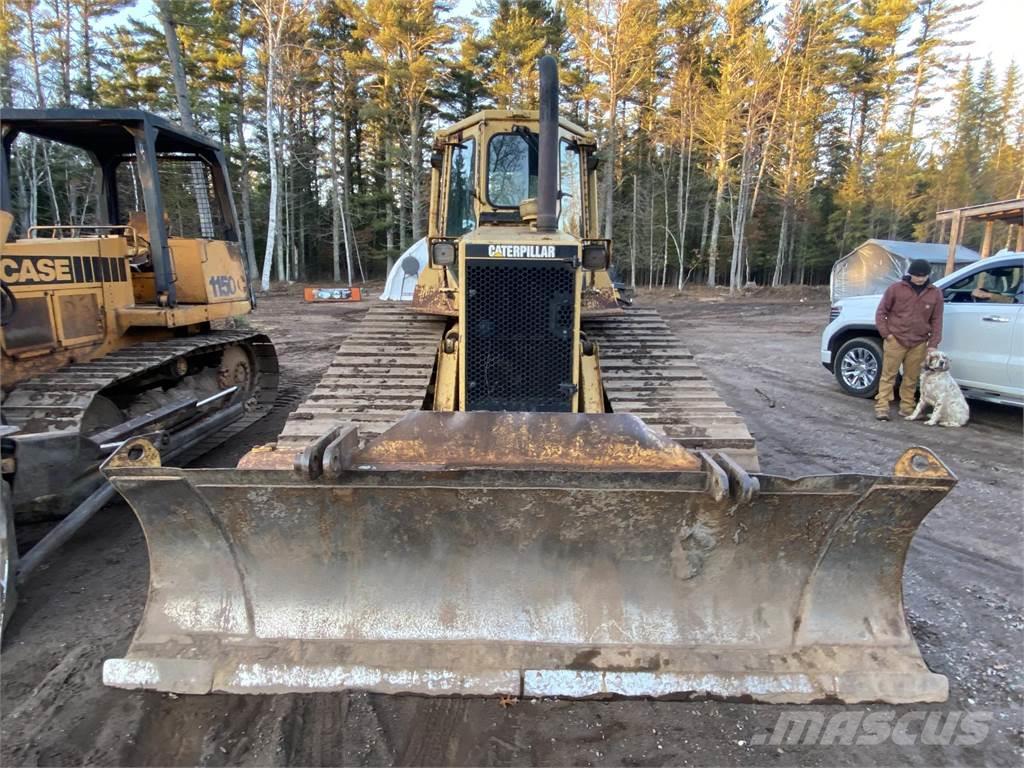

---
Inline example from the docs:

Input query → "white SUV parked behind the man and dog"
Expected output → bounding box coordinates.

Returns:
[821,253,1024,406]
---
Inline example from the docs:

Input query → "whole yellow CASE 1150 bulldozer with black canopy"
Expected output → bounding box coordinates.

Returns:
[0,109,278,623]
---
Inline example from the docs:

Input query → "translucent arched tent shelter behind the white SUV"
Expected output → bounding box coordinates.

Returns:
[828,240,981,303]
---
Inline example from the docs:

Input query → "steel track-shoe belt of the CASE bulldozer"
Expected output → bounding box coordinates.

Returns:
[3,331,278,444]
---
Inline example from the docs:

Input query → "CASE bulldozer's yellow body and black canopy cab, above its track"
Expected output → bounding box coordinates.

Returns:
[0,109,252,388]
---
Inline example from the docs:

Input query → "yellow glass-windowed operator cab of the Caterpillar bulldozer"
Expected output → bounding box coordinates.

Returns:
[413,102,623,316]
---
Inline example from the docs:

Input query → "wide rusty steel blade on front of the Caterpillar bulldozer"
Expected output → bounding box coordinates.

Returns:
[103,413,955,702]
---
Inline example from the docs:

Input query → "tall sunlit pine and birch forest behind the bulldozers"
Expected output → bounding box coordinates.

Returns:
[0,0,1024,289]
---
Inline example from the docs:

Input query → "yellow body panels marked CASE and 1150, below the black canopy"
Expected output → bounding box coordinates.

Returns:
[0,233,251,389]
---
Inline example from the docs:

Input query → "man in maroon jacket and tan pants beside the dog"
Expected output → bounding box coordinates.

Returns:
[874,259,942,421]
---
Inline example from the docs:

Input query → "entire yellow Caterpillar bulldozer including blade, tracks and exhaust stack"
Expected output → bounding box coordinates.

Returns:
[103,57,955,702]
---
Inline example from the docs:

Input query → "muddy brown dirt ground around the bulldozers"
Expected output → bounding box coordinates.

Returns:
[0,290,1024,766]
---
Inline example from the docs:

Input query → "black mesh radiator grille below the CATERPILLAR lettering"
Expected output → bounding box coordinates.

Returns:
[463,258,575,412]
